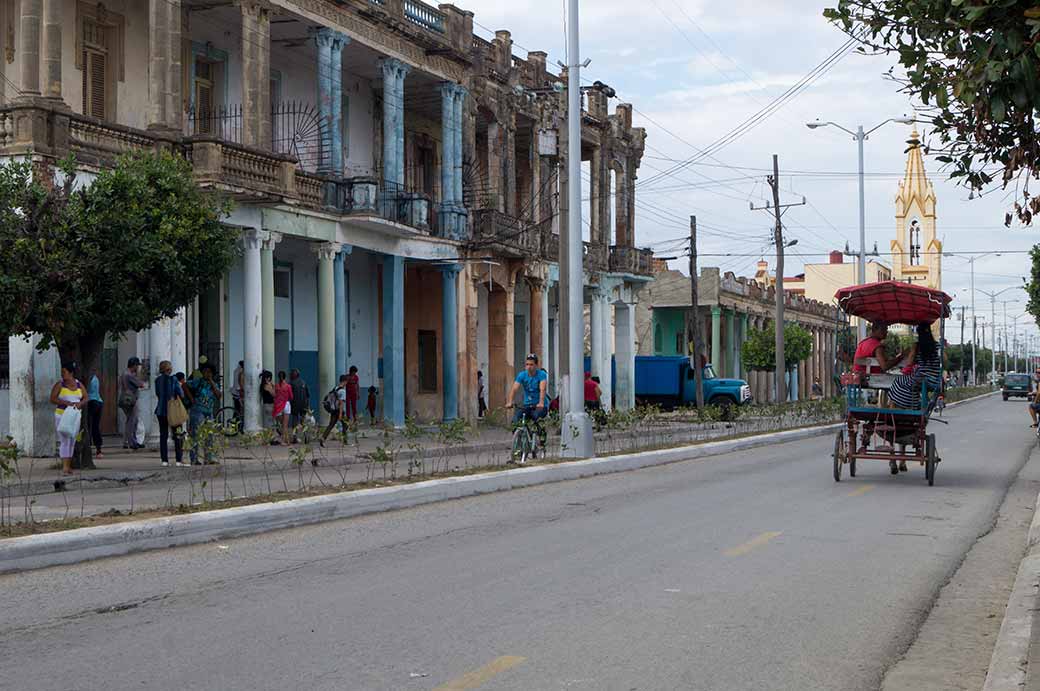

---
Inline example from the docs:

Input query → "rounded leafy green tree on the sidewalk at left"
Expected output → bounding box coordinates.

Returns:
[0,152,237,467]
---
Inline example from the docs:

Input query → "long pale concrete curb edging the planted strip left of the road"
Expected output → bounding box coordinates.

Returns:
[0,385,989,573]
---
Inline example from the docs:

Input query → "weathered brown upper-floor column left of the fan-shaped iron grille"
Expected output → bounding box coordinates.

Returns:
[239,0,270,148]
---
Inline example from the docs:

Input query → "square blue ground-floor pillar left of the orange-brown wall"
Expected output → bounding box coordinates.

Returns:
[383,255,405,427]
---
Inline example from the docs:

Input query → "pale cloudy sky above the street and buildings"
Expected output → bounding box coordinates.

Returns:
[458,0,1040,351]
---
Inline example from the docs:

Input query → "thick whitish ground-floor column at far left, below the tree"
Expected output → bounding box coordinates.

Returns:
[7,335,61,458]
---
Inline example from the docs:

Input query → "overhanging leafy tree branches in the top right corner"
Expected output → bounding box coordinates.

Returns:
[824,0,1040,226]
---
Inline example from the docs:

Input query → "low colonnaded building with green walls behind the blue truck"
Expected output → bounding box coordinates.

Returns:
[636,267,837,402]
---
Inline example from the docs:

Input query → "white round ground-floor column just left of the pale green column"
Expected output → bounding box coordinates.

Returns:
[242,230,266,432]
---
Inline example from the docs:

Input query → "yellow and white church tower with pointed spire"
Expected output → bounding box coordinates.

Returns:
[891,129,942,289]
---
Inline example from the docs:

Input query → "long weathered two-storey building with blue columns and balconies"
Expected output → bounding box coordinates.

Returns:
[0,0,650,454]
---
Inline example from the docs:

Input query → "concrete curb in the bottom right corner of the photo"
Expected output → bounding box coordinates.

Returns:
[983,495,1040,691]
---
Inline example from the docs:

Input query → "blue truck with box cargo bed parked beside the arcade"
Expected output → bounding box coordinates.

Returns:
[635,355,751,409]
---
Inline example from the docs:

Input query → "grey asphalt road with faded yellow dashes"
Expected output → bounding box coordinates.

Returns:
[0,399,1032,691]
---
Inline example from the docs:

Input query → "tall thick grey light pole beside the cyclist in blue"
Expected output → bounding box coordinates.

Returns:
[560,0,594,458]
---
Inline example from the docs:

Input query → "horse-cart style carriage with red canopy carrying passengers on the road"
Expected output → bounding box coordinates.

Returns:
[833,281,952,485]
